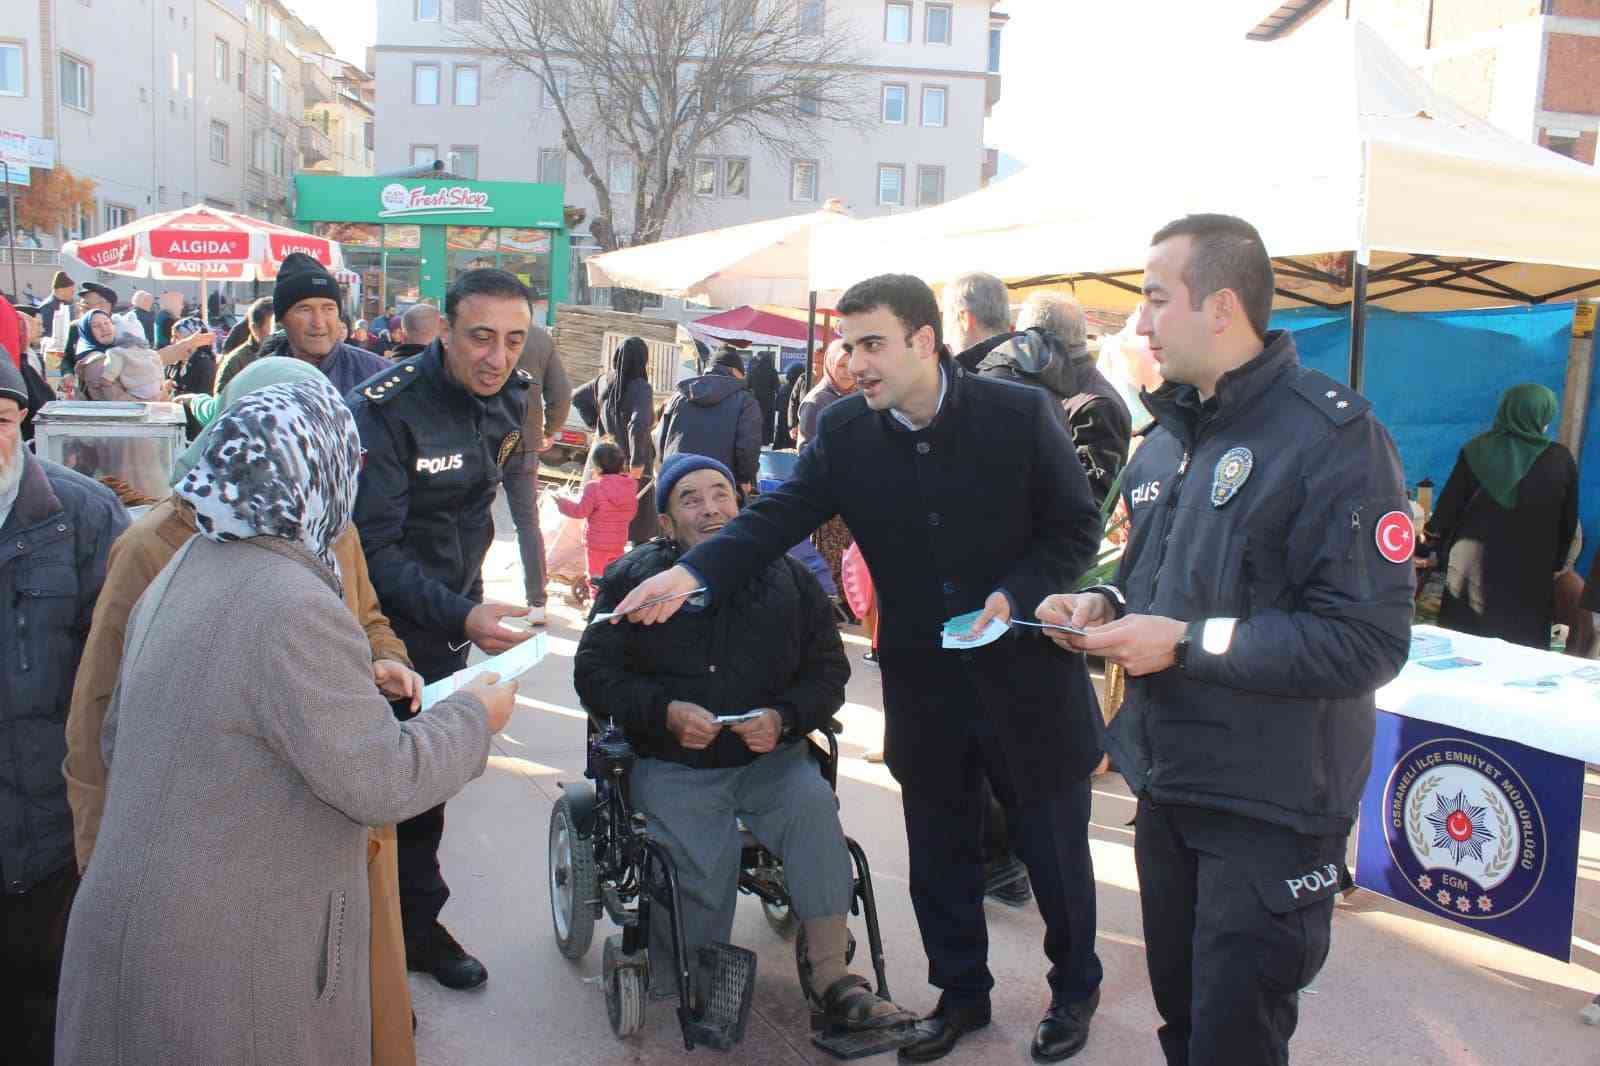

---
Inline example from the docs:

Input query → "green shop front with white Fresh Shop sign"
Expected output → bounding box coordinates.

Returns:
[294,174,568,323]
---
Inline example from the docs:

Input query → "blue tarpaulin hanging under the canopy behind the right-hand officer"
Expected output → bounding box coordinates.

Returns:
[1272,304,1600,573]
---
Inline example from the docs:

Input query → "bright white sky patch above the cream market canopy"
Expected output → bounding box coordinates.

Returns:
[986,0,1278,162]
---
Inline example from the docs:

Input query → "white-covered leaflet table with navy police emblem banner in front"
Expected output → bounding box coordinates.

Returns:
[1355,626,1600,962]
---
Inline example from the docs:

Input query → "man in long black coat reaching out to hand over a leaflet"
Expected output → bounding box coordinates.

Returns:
[604,275,1101,1061]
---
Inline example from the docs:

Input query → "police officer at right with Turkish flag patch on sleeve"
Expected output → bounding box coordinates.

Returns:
[1038,214,1411,1066]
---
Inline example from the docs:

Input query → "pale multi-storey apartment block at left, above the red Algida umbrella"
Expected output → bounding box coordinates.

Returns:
[0,0,371,293]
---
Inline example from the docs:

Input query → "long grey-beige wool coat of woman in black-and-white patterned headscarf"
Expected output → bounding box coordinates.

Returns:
[56,538,490,1066]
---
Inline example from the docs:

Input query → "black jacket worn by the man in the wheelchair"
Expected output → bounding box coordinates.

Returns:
[573,539,850,770]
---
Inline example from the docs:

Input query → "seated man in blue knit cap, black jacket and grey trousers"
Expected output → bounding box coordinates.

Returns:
[574,453,912,1032]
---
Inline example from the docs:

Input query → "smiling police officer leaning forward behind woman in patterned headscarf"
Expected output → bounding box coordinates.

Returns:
[347,271,533,989]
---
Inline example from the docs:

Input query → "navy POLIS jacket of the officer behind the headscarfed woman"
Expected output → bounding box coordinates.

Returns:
[346,341,531,663]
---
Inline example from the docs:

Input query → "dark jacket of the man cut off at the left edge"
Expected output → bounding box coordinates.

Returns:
[0,453,128,893]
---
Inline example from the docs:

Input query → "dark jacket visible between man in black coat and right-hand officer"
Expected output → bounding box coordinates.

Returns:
[957,328,1133,504]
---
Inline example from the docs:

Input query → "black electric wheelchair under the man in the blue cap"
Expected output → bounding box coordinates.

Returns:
[549,714,912,1058]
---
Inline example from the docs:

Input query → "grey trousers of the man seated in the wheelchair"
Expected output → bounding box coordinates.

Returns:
[632,741,854,991]
